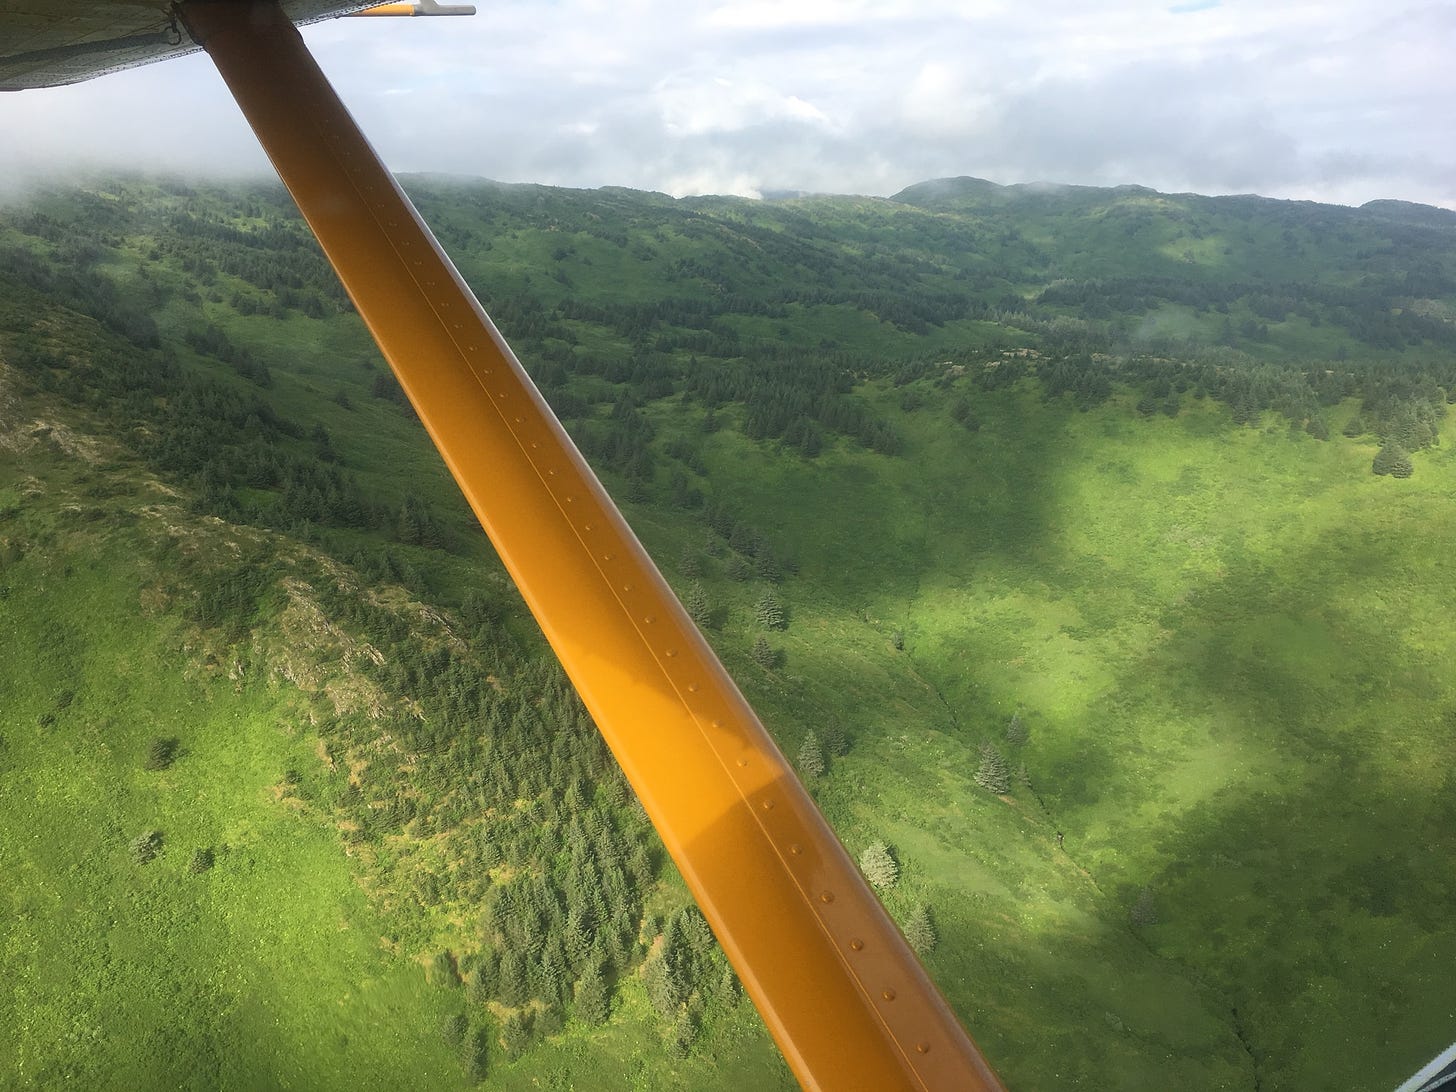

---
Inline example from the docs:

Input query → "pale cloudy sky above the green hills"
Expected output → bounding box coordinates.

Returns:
[0,0,1456,208]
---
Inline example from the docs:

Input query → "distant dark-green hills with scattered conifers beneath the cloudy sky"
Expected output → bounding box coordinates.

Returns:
[0,178,1456,503]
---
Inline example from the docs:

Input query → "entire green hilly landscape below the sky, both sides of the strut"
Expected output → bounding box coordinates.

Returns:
[0,179,1456,1089]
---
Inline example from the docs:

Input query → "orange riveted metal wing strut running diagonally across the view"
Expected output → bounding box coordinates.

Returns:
[181,0,1002,1092]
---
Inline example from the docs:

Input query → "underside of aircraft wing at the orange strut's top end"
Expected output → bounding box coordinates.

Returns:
[0,0,370,90]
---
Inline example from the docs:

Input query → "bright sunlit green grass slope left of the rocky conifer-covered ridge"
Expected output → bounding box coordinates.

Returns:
[0,501,462,1089]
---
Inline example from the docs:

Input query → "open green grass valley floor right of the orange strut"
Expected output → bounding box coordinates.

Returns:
[693,390,1456,1088]
